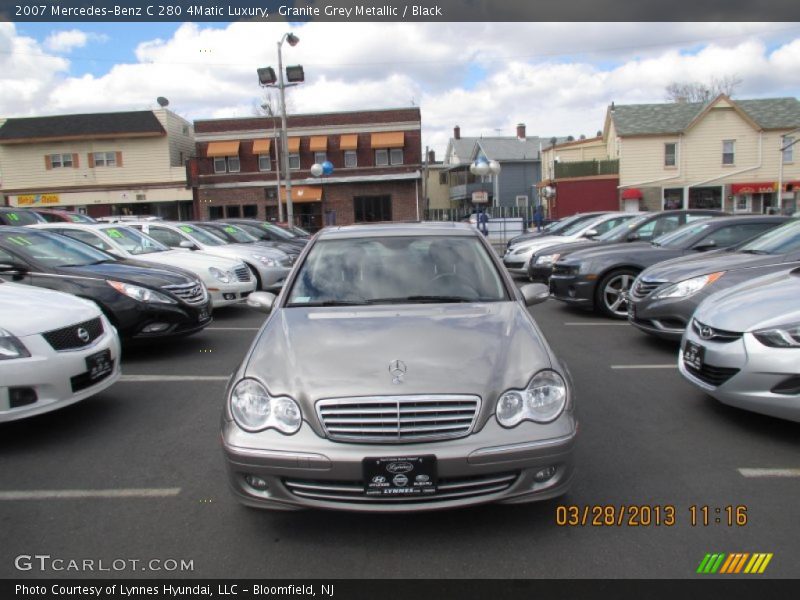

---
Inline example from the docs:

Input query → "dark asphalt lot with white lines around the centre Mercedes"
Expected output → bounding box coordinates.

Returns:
[0,301,800,578]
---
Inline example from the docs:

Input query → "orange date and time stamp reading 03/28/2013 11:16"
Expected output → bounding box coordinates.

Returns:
[556,504,748,527]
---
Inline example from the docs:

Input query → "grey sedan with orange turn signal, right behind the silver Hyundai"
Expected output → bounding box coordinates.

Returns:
[628,219,800,341]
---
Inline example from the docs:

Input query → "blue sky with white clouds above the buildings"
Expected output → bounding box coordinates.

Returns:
[0,22,800,156]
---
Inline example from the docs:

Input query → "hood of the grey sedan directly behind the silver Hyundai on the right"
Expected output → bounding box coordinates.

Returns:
[642,250,786,283]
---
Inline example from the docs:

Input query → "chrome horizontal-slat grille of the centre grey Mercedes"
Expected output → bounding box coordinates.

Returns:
[317,395,481,444]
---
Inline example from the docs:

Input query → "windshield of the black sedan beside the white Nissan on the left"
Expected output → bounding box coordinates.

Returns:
[0,231,115,267]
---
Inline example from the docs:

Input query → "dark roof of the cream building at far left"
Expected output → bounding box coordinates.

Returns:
[0,110,166,143]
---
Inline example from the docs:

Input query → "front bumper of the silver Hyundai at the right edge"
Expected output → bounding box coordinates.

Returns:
[678,328,800,421]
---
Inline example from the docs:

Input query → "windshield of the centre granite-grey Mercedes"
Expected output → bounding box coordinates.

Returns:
[287,236,508,307]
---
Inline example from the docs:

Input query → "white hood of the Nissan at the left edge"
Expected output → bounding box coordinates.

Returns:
[0,283,100,337]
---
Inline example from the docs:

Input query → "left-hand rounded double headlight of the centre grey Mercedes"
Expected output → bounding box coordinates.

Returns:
[230,379,303,435]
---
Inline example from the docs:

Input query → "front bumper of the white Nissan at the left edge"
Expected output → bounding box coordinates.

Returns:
[0,319,121,423]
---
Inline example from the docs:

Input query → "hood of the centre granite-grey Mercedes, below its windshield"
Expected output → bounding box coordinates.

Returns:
[244,302,552,410]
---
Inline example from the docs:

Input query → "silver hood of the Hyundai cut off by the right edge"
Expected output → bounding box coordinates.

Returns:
[695,269,800,331]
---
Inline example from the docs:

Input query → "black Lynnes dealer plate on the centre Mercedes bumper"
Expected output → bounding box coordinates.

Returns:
[363,455,437,497]
